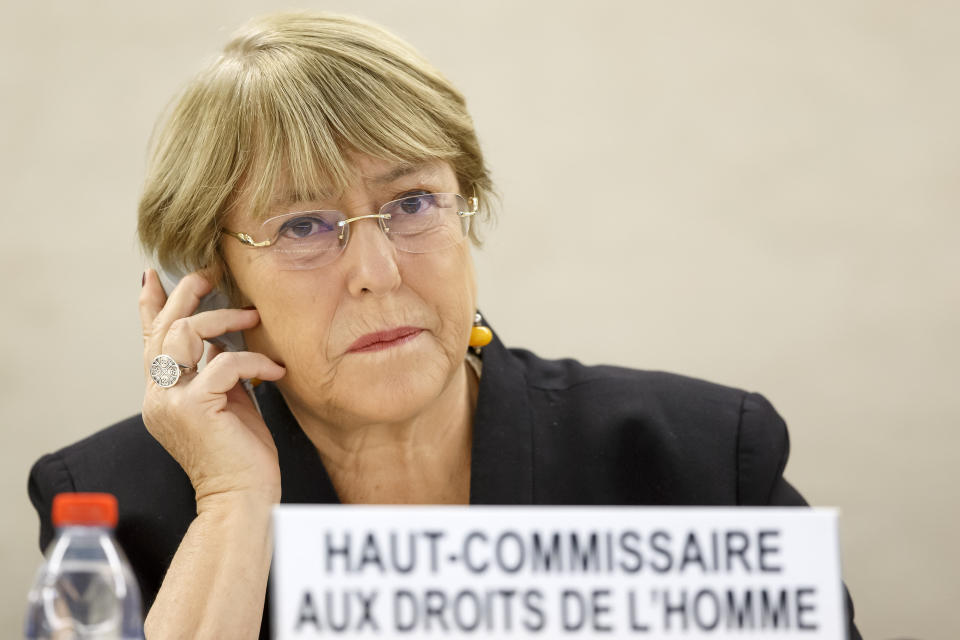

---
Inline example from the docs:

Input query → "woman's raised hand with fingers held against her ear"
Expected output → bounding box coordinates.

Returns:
[140,269,285,510]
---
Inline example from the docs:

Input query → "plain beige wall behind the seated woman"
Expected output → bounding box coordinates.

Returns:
[0,0,960,639]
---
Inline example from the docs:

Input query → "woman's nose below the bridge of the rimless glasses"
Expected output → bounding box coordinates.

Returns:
[340,218,400,296]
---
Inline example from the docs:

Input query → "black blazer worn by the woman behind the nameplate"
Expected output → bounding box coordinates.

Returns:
[29,338,860,638]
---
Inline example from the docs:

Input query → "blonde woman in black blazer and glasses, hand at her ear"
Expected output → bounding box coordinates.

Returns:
[30,14,864,638]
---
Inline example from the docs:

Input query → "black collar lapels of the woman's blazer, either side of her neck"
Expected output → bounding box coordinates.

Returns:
[257,324,533,504]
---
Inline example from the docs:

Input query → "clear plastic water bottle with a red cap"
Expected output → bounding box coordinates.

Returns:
[24,493,143,640]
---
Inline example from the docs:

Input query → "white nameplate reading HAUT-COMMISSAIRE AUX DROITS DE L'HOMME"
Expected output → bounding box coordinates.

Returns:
[271,505,846,640]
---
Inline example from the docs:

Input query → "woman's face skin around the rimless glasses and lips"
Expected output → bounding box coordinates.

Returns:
[223,155,476,426]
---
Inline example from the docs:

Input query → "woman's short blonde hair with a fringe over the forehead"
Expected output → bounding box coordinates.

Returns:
[138,13,494,296]
